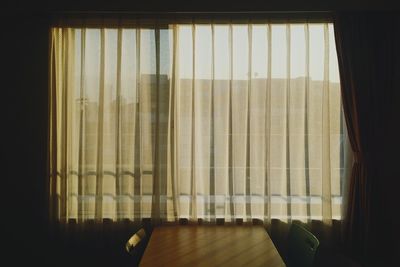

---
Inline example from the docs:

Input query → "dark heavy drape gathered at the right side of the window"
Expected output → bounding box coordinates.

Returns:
[334,12,400,266]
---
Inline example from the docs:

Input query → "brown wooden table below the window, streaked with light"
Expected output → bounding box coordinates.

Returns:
[140,225,285,267]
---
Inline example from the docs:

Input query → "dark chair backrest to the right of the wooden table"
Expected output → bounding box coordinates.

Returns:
[288,223,319,267]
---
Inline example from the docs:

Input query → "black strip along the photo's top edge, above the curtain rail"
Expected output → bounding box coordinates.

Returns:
[5,0,395,12]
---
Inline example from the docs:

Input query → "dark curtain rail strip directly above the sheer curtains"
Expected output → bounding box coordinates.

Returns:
[50,11,333,26]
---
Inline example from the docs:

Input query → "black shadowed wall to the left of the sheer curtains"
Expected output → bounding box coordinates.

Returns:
[1,14,48,266]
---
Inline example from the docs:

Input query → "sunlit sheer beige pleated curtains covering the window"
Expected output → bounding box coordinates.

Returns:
[50,23,350,224]
